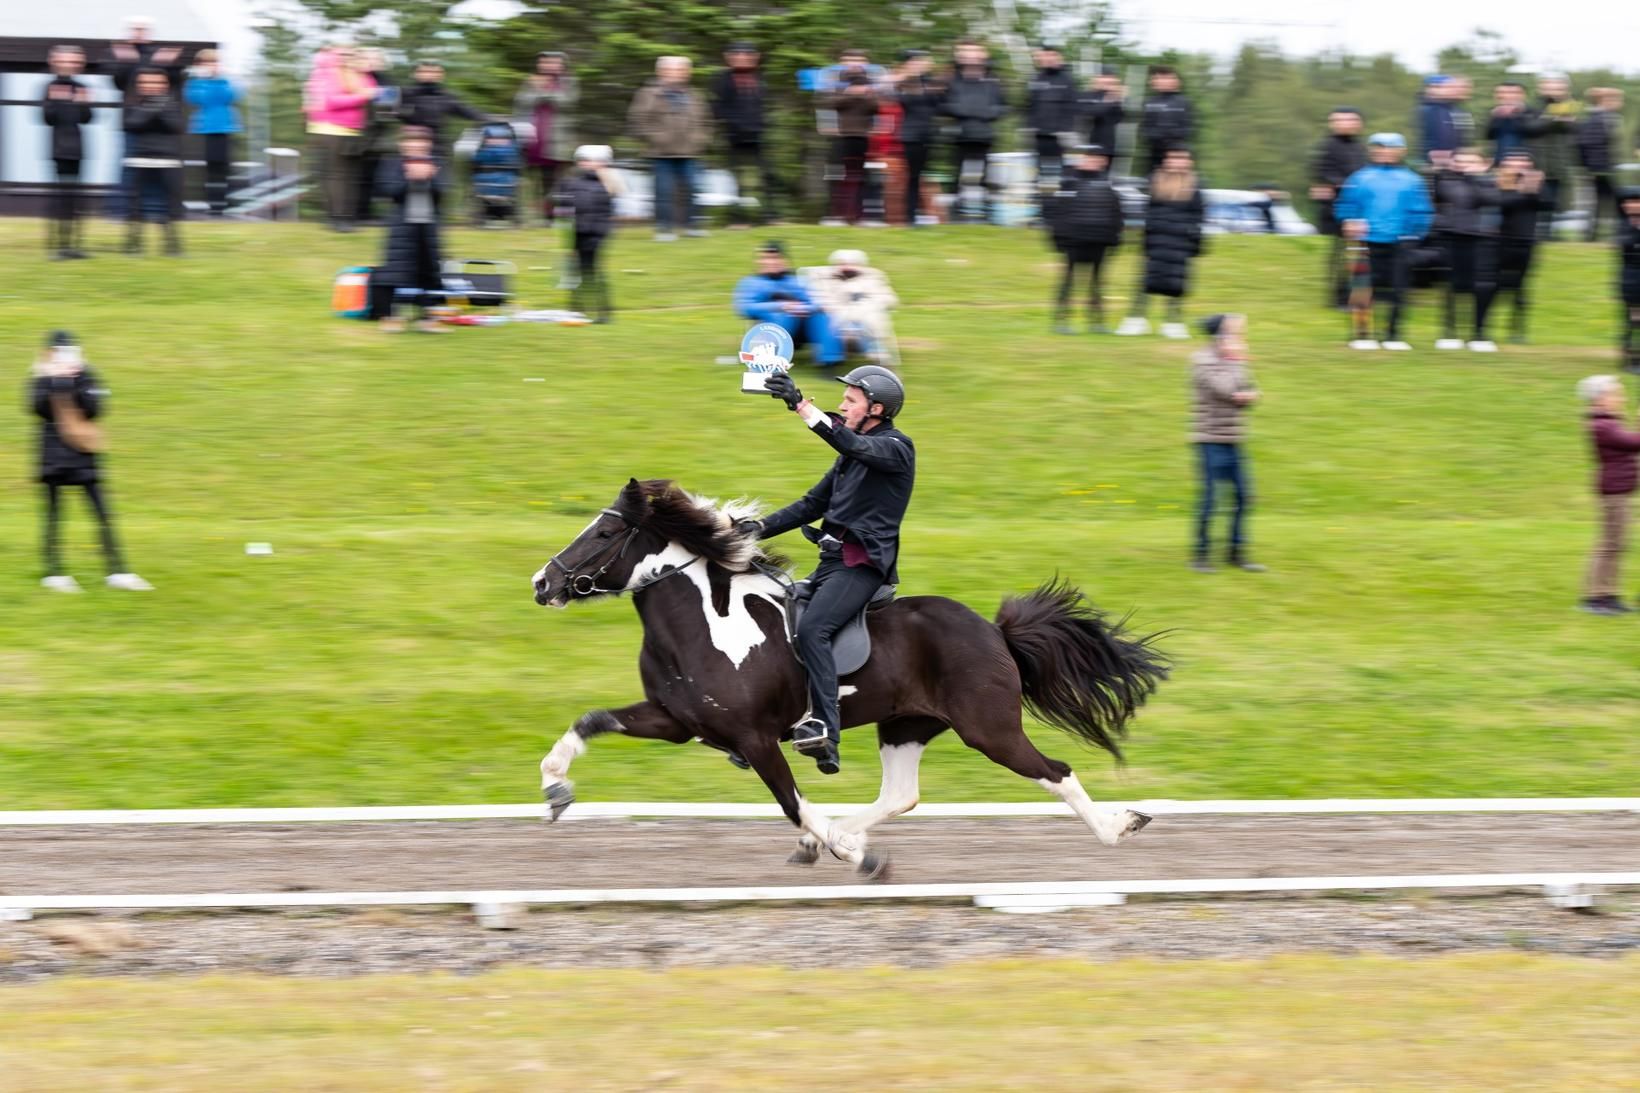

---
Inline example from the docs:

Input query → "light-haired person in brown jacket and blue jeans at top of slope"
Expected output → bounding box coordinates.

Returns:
[626,57,712,243]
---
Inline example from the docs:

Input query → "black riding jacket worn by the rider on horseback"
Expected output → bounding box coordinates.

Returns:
[763,414,917,584]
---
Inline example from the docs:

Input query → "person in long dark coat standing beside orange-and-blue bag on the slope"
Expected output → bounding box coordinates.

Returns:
[371,125,448,333]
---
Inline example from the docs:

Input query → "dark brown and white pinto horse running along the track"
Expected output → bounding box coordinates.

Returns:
[531,479,1168,880]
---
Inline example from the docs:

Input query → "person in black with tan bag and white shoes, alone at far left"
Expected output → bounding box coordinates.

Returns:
[28,330,154,592]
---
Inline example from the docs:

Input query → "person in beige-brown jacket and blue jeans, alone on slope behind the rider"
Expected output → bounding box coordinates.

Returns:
[1191,315,1264,573]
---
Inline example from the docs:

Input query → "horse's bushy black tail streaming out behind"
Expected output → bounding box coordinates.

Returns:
[997,578,1168,761]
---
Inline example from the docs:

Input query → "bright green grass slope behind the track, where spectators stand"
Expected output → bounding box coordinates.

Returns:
[0,222,1640,807]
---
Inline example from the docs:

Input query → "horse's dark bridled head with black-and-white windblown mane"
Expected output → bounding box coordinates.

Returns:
[530,479,759,607]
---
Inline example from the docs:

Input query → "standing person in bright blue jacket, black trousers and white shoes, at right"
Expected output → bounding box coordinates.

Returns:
[1333,133,1435,350]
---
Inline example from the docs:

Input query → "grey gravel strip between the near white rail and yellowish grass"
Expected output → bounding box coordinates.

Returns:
[0,893,1640,983]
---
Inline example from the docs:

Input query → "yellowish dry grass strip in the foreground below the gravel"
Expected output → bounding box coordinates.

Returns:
[0,955,1640,1093]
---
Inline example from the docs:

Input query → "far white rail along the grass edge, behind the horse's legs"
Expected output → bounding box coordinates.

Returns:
[0,798,1640,827]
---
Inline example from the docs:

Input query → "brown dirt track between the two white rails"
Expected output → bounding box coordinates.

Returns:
[0,812,1640,894]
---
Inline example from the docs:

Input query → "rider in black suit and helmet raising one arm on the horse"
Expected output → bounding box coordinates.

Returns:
[746,364,917,775]
